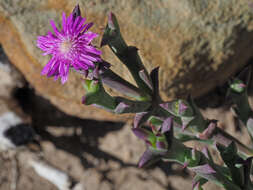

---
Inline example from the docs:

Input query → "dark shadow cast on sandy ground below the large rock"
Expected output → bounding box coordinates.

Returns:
[11,84,189,189]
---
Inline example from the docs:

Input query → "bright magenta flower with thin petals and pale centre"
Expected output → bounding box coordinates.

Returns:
[37,8,101,84]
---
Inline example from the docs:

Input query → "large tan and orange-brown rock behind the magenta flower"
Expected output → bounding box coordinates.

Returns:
[0,0,253,120]
